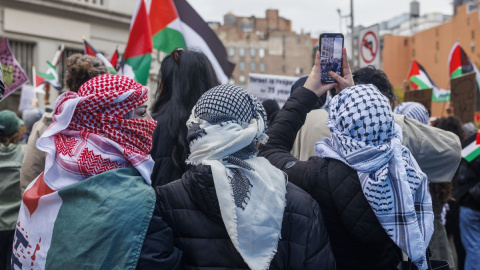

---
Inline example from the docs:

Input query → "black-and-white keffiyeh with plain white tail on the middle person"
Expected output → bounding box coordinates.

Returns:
[187,85,286,269]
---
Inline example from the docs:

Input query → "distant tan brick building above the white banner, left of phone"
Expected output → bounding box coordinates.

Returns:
[210,9,313,89]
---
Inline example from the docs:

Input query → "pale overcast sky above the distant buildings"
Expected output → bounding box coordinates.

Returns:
[187,0,453,36]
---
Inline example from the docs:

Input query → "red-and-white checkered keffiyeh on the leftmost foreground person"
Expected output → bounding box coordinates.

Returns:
[37,74,156,189]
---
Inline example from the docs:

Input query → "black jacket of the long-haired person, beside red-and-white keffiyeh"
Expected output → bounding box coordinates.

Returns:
[150,113,191,188]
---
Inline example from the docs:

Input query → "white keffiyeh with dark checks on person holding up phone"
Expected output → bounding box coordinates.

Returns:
[315,84,433,269]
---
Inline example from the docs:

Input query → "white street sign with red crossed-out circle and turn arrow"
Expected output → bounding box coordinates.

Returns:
[359,24,380,68]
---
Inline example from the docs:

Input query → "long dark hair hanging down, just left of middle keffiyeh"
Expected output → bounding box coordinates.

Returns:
[152,50,220,177]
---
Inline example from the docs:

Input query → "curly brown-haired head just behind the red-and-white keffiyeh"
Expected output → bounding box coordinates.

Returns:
[65,53,108,92]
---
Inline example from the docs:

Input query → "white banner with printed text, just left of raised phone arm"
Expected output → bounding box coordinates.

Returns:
[248,73,298,108]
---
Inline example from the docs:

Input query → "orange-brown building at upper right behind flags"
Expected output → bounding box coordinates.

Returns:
[382,4,480,116]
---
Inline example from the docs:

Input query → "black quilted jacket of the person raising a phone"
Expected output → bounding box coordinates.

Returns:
[259,87,401,269]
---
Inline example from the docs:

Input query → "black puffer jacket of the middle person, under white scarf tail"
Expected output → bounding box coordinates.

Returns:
[157,165,335,269]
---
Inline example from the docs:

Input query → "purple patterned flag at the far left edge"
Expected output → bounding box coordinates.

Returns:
[0,38,29,100]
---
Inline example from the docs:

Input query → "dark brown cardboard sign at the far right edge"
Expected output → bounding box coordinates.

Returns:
[450,72,477,123]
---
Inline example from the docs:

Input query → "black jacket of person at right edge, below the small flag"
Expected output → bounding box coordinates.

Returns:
[453,134,480,211]
